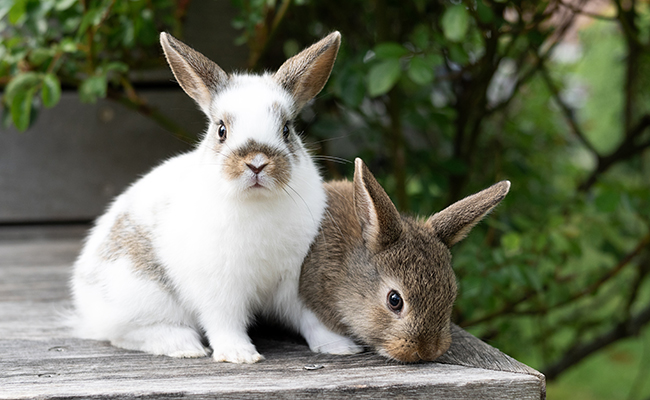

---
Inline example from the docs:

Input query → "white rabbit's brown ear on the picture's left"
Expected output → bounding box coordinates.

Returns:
[160,32,228,113]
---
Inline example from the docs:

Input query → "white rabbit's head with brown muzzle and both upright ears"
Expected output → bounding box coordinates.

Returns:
[160,32,340,194]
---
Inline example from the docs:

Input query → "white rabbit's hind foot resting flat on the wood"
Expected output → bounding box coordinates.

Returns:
[111,324,210,358]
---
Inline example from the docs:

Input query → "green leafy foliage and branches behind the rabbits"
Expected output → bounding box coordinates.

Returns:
[0,0,650,398]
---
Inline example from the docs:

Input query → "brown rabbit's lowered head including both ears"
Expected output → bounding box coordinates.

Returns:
[336,159,510,362]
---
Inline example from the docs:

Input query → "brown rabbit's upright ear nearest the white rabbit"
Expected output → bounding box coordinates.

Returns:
[354,158,402,252]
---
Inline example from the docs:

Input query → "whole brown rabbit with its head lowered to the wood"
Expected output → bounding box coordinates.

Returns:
[300,158,510,362]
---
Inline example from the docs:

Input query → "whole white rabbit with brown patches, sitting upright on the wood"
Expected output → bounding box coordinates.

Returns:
[71,32,360,363]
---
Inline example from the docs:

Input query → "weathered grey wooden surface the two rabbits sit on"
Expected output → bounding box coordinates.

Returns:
[0,229,545,399]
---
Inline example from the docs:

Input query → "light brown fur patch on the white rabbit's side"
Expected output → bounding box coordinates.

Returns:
[101,214,171,291]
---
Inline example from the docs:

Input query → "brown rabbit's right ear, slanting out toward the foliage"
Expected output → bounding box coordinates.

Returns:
[426,181,510,247]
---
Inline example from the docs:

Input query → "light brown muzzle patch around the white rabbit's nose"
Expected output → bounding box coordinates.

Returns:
[223,139,291,189]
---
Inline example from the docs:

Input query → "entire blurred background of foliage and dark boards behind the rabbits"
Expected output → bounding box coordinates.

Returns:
[0,0,650,400]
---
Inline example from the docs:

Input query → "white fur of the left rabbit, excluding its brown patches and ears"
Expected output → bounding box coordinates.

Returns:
[72,75,344,363]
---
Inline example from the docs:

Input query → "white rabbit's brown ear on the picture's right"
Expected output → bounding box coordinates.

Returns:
[273,32,341,109]
